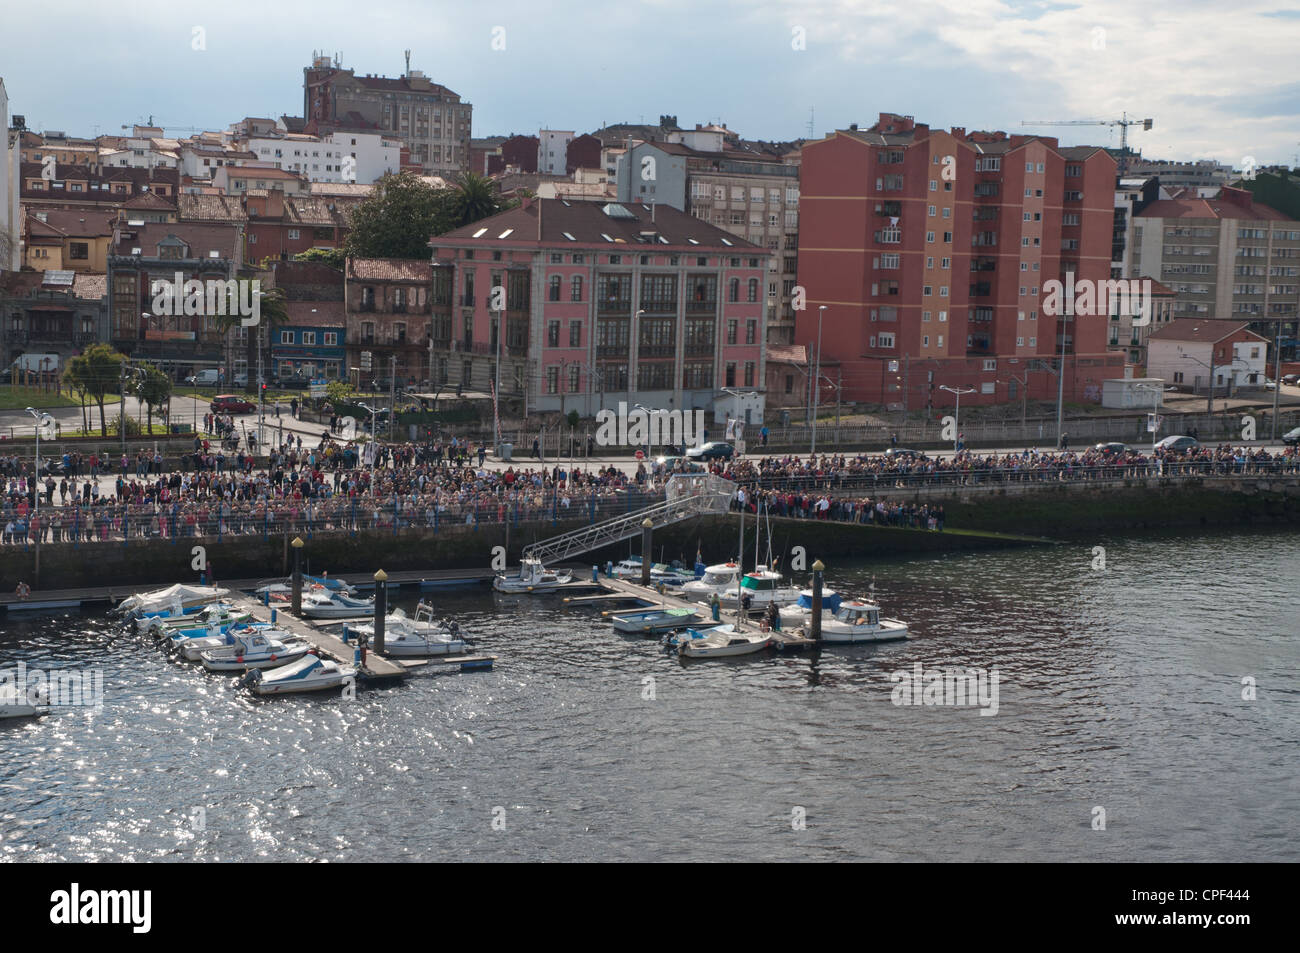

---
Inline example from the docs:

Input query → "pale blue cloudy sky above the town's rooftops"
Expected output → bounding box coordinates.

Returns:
[0,0,1300,168]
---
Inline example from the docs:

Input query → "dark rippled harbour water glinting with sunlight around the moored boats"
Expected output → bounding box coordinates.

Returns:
[0,533,1300,861]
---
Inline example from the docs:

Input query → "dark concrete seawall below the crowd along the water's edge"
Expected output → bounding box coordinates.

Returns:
[0,477,1300,593]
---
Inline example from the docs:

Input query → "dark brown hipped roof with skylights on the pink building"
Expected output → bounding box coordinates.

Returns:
[434,199,767,250]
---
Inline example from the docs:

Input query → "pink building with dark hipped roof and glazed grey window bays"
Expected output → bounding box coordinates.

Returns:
[430,199,768,419]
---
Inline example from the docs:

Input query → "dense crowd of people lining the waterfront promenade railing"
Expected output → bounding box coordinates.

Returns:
[0,433,1300,545]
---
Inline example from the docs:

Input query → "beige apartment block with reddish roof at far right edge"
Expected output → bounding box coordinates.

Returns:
[1132,187,1300,360]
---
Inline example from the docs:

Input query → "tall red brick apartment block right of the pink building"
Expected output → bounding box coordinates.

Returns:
[796,113,1123,410]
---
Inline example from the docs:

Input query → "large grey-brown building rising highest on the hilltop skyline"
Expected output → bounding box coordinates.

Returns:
[302,56,473,181]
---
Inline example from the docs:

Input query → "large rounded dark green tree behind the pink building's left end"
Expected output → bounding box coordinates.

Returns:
[345,172,458,260]
